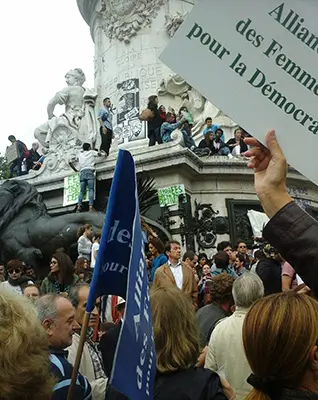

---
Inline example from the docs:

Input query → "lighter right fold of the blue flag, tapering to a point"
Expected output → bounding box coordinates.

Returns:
[110,194,156,400]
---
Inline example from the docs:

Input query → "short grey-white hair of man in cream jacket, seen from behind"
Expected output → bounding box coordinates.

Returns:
[232,271,264,308]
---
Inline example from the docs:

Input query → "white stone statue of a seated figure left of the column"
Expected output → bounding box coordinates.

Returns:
[34,68,99,172]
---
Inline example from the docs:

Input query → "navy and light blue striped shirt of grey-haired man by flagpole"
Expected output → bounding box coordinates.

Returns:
[50,348,92,400]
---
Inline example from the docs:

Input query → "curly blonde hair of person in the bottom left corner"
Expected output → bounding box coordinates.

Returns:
[0,287,55,400]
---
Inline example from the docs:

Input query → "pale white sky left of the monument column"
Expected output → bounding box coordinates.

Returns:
[0,0,94,155]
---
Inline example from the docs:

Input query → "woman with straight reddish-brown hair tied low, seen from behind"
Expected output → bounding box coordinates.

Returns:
[243,291,318,400]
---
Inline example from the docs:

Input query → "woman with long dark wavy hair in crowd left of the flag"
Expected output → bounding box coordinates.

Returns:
[41,252,78,295]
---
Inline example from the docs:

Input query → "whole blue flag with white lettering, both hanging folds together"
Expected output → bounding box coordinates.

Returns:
[86,150,156,400]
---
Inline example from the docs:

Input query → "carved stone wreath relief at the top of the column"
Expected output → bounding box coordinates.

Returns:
[100,0,166,43]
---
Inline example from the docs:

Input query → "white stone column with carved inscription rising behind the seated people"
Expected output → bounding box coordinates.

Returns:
[77,0,235,151]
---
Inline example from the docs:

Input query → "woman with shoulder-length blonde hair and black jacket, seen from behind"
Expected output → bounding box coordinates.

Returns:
[150,287,226,400]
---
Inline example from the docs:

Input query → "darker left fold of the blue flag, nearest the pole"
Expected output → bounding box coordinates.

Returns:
[86,150,136,312]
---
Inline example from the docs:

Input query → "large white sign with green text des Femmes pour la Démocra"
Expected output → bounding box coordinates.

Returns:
[160,0,318,184]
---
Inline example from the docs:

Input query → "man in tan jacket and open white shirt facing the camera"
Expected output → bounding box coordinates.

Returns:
[153,240,198,308]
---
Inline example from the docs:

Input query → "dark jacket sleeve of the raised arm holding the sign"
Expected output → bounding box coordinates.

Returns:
[263,202,318,297]
